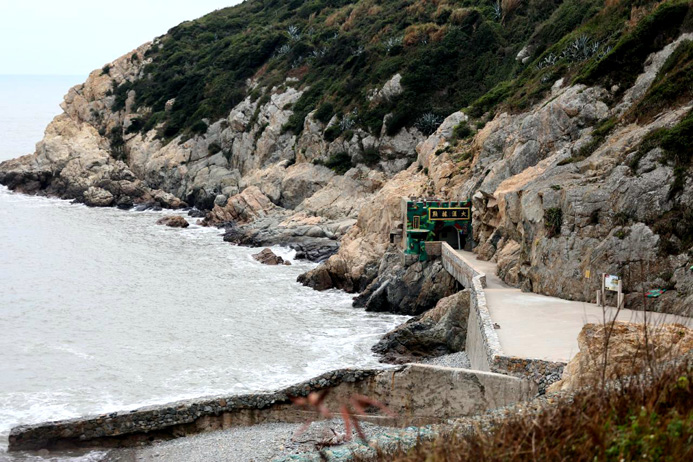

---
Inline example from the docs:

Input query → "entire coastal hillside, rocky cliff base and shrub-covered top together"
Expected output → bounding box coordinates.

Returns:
[0,0,693,311]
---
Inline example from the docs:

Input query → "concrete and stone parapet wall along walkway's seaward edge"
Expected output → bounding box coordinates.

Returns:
[441,242,565,391]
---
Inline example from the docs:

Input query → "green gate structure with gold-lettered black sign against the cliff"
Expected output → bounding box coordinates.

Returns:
[404,200,472,261]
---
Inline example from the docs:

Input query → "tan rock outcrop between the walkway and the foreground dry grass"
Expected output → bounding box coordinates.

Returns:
[549,322,693,391]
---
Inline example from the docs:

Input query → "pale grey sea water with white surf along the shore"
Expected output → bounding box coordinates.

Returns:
[0,78,406,461]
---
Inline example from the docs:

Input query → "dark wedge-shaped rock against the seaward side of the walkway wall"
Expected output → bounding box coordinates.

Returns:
[373,290,469,364]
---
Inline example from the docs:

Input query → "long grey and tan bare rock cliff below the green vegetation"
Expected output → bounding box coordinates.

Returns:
[0,19,693,322]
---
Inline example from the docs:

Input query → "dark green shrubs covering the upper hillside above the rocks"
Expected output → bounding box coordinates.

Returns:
[103,0,693,175]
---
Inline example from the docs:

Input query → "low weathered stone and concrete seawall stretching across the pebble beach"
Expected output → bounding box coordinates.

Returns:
[9,365,536,451]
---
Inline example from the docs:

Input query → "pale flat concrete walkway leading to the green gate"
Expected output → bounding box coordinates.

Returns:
[458,251,693,362]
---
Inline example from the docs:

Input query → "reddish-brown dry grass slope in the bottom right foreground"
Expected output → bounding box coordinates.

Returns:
[364,360,693,462]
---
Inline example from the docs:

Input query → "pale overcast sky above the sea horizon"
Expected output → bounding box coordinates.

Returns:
[0,0,240,76]
